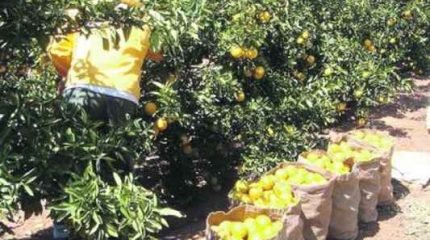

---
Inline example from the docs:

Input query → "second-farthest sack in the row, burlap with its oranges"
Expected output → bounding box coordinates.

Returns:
[327,139,381,223]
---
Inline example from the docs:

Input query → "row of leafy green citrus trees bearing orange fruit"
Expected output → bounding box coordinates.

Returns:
[0,0,430,239]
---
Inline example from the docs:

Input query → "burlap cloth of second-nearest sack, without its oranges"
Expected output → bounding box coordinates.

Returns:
[229,190,304,240]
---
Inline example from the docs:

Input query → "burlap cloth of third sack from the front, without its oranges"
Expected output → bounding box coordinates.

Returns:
[268,162,334,240]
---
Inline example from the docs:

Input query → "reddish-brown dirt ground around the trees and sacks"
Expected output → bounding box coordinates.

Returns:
[0,79,430,240]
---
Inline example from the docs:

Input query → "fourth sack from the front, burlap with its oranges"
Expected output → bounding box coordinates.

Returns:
[298,150,360,239]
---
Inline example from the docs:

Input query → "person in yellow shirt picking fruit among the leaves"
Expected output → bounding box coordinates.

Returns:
[47,1,163,126]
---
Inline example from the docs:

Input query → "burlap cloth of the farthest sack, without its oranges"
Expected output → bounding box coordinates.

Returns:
[347,129,394,205]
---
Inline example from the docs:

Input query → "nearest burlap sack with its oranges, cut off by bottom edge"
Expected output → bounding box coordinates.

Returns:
[206,205,288,240]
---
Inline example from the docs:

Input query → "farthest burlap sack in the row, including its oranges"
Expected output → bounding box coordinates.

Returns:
[347,129,394,205]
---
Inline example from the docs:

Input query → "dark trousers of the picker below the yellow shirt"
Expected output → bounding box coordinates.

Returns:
[63,88,137,126]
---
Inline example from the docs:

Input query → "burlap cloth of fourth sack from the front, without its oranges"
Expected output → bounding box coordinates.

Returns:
[299,150,360,239]
